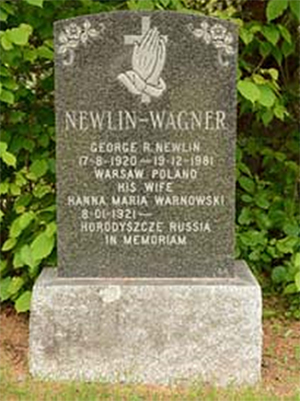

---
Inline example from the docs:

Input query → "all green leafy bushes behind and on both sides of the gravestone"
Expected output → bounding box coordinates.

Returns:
[0,0,300,317]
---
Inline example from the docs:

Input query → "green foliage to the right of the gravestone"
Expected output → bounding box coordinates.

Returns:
[236,0,300,318]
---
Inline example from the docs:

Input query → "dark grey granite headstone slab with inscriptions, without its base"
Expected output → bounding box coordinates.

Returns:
[55,12,237,277]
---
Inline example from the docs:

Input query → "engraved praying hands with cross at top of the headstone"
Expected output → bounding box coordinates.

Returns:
[118,17,167,103]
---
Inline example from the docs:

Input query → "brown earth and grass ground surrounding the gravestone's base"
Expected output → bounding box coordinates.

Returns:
[0,299,300,401]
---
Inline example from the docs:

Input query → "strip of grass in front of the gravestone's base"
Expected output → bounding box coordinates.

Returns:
[0,368,300,401]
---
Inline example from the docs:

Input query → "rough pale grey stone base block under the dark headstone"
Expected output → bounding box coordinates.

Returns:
[30,262,262,386]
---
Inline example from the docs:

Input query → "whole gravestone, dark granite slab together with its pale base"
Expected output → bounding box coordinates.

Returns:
[30,12,261,384]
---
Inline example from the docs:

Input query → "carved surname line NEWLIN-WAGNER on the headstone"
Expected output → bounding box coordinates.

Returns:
[64,110,227,132]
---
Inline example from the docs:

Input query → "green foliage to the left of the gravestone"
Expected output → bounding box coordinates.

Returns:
[0,0,55,312]
